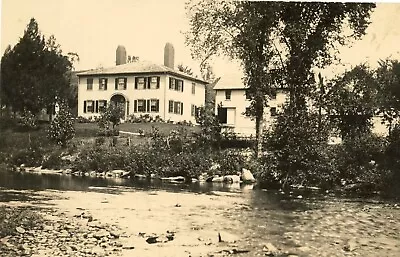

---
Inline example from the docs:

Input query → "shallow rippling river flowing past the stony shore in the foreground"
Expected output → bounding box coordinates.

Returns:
[0,168,400,256]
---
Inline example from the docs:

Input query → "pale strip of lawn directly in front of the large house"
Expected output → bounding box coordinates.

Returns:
[75,122,200,137]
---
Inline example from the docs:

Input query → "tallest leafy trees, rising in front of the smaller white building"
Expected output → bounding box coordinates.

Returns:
[186,0,375,154]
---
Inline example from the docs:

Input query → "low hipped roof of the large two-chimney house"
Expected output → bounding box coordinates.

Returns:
[77,61,208,84]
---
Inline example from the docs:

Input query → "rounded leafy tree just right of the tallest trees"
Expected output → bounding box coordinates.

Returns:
[325,65,378,140]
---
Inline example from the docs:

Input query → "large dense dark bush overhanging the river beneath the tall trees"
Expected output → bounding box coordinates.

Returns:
[265,109,336,186]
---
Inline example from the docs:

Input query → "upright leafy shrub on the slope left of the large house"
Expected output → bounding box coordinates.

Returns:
[47,103,75,147]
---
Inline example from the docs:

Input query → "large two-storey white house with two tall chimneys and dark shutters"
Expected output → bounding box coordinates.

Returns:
[77,43,207,123]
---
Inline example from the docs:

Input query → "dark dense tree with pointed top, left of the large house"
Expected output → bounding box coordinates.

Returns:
[1,18,77,114]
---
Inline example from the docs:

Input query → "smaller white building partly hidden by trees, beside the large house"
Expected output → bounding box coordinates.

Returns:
[214,76,287,136]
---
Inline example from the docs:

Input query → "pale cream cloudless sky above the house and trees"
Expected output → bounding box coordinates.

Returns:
[0,0,400,82]
